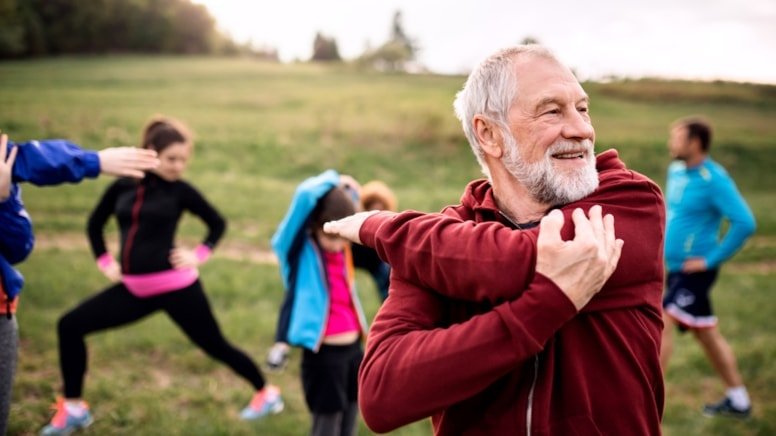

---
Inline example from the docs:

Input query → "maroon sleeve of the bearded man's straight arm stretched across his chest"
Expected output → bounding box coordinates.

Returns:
[359,170,665,304]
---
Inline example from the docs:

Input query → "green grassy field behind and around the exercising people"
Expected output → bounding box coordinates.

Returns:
[0,57,776,435]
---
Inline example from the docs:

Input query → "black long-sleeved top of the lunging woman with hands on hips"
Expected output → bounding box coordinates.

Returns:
[87,173,226,274]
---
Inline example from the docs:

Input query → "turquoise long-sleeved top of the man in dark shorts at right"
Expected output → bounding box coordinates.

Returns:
[665,157,755,272]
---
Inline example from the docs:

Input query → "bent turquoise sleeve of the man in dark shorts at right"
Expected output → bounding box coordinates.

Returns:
[706,169,755,268]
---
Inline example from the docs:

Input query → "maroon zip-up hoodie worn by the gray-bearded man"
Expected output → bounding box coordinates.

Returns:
[359,150,665,435]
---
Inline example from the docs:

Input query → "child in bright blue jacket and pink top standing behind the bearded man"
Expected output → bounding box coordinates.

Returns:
[269,170,367,436]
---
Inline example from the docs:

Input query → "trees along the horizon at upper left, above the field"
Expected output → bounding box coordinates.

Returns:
[0,0,418,71]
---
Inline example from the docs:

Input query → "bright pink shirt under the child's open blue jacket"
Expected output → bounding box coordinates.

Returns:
[323,251,361,337]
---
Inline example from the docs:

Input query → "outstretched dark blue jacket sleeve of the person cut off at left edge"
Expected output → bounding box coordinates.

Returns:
[8,139,100,186]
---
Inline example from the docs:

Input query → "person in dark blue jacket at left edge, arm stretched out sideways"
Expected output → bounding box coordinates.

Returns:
[0,134,159,434]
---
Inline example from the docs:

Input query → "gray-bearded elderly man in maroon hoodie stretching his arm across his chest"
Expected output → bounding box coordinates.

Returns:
[328,45,665,435]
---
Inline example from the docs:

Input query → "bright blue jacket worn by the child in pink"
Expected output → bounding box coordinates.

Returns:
[272,170,366,351]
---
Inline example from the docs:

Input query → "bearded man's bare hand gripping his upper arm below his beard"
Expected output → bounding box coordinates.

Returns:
[536,205,624,310]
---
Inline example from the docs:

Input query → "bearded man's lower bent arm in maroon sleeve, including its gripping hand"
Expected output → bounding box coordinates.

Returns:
[359,211,622,432]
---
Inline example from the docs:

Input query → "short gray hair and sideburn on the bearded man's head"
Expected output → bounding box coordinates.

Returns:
[453,44,560,178]
